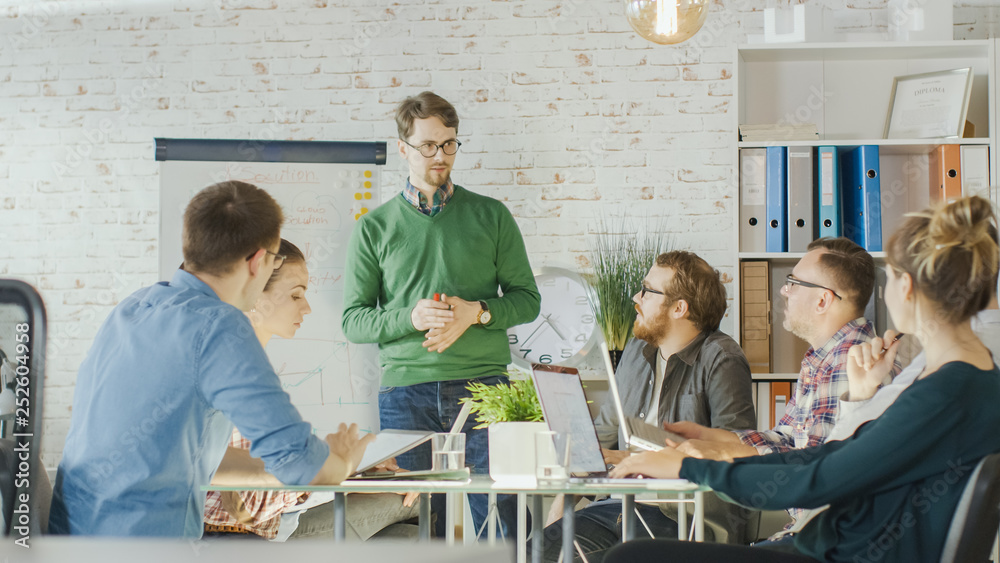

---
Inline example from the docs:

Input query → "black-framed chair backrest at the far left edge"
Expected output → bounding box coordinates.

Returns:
[0,279,51,541]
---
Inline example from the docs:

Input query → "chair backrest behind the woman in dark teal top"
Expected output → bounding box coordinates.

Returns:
[941,453,1000,563]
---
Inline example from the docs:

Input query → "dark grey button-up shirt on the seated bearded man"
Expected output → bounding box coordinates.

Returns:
[594,330,757,449]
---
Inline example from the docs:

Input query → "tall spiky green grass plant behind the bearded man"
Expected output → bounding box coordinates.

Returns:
[584,216,671,367]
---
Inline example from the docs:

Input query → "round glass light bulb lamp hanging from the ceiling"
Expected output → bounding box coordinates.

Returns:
[623,0,708,45]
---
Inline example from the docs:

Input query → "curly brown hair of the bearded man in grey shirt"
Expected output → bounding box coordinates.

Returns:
[656,250,726,331]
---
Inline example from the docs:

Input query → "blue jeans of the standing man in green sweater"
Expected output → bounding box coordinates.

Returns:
[378,375,530,538]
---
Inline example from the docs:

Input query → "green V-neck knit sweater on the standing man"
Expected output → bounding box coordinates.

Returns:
[342,185,541,386]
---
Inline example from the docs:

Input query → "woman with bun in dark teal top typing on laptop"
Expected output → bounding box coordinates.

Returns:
[605,197,1000,563]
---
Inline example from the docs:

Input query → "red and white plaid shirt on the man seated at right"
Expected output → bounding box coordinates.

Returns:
[736,317,899,529]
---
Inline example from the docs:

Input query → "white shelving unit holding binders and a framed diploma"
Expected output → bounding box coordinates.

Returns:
[733,39,998,381]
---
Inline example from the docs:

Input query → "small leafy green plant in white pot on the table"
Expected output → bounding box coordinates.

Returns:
[461,378,548,485]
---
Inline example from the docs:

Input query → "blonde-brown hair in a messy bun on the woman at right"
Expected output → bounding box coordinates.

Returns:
[887,196,1000,323]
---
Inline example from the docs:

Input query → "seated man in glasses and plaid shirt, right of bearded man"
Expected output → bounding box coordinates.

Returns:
[666,237,899,525]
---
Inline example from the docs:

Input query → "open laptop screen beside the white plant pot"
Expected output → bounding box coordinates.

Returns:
[532,364,607,475]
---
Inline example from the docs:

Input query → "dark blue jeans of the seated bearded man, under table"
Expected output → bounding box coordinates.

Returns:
[528,499,677,563]
